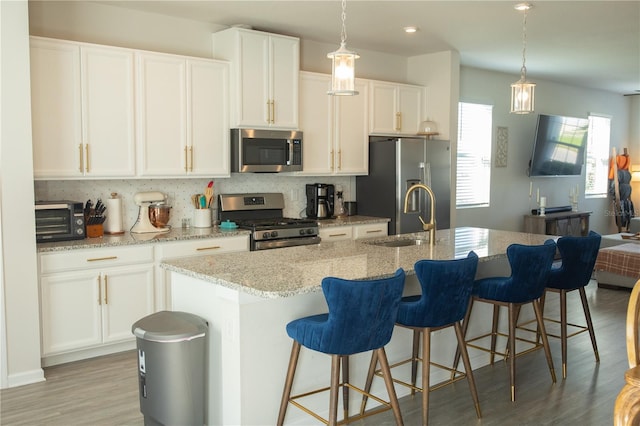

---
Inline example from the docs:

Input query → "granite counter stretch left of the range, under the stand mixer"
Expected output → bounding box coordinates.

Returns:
[37,226,249,253]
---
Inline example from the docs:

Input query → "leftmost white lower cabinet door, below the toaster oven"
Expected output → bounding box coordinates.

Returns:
[40,270,102,355]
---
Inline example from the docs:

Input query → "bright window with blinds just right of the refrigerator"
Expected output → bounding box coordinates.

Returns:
[456,102,493,208]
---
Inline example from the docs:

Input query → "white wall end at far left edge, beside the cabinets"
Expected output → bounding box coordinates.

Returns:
[0,1,44,387]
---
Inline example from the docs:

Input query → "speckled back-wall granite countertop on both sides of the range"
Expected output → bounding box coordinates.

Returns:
[37,216,389,253]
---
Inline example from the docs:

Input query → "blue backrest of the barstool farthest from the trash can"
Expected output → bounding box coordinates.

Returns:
[547,231,602,290]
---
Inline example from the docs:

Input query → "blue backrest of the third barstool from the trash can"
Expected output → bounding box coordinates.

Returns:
[500,240,556,303]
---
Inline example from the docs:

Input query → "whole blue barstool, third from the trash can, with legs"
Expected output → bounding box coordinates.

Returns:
[455,240,556,401]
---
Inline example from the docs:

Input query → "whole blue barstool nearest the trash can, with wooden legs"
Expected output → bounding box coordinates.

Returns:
[277,269,405,425]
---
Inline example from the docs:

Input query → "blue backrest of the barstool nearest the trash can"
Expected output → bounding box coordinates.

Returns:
[316,268,405,355]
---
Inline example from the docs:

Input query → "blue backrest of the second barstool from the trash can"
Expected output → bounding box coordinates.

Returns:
[399,251,478,327]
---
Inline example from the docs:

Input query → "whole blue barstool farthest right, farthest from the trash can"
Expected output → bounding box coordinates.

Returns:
[541,231,602,379]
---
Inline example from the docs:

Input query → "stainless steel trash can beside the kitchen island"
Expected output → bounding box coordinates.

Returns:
[131,311,208,426]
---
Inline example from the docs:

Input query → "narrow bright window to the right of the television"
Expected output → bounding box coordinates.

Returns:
[584,114,611,197]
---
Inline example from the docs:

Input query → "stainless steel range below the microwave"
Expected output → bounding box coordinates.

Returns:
[218,193,320,251]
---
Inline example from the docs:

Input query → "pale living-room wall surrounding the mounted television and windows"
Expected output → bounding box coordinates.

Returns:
[457,67,640,234]
